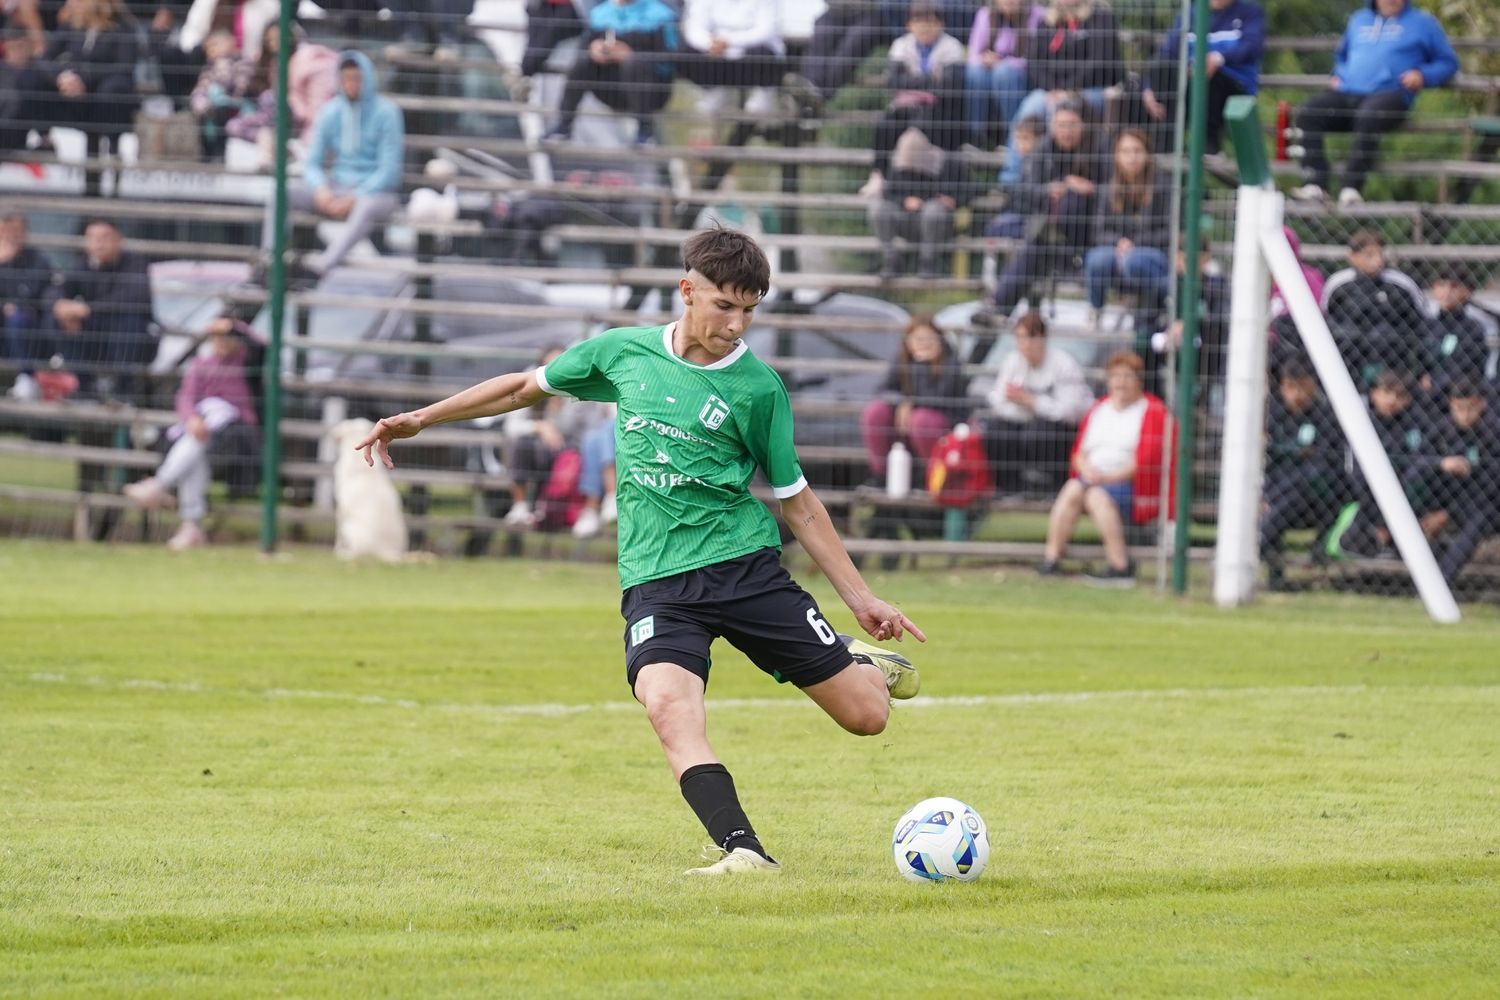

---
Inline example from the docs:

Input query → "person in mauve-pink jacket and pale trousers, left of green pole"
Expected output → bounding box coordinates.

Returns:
[125,316,260,552]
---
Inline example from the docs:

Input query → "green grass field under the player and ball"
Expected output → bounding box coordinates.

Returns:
[0,543,1500,997]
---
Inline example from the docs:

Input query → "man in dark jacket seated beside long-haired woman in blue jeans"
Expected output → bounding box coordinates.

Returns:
[971,100,1104,338]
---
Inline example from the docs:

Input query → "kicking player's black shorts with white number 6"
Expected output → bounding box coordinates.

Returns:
[620,549,851,691]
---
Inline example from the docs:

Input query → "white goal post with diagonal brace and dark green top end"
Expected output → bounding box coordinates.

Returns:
[1214,97,1460,624]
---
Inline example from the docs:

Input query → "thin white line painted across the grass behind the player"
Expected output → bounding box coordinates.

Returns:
[17,673,1500,718]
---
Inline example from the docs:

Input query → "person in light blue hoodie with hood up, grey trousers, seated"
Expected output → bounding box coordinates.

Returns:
[261,49,407,274]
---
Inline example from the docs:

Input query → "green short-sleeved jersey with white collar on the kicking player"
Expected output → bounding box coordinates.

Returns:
[537,324,807,588]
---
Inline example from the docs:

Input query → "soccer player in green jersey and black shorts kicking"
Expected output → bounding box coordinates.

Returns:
[357,229,927,876]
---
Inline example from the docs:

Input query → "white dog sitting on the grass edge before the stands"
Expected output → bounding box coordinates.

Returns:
[329,420,407,562]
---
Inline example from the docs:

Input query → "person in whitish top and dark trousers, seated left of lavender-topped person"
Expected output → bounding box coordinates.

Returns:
[860,1,965,198]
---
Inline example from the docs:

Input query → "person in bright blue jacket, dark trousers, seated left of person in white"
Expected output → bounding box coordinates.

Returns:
[543,0,680,144]
